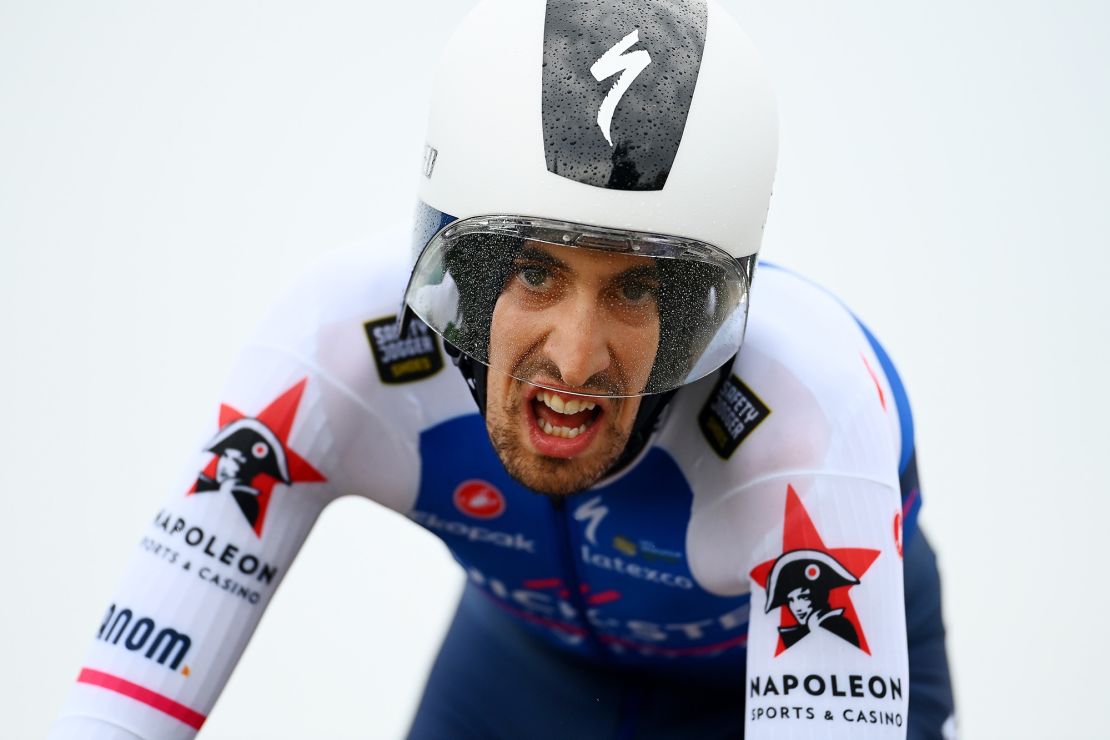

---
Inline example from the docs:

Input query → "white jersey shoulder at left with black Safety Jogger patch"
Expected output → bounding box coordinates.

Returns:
[236,229,473,510]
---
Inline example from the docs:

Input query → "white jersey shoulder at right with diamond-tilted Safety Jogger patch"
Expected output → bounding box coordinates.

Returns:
[659,265,900,595]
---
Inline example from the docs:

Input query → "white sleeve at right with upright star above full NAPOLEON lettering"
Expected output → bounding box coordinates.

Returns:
[741,472,910,740]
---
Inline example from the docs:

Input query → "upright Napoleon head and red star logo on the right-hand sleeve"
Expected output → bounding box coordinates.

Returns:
[751,486,879,656]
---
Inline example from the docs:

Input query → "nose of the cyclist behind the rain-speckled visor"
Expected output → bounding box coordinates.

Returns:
[544,296,611,386]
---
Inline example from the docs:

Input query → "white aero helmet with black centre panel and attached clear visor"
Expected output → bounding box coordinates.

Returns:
[405,0,777,396]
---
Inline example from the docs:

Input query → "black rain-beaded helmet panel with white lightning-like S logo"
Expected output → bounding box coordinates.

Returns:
[543,0,707,190]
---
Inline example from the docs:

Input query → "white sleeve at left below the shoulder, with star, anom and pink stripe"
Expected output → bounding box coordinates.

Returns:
[50,346,336,740]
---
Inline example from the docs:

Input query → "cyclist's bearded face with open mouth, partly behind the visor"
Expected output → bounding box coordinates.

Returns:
[486,242,659,494]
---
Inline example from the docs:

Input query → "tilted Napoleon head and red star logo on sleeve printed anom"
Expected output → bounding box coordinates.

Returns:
[188,378,326,537]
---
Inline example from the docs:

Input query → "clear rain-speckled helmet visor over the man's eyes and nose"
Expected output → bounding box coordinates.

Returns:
[405,216,753,396]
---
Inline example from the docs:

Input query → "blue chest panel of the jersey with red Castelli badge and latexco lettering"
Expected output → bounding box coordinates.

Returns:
[410,414,749,676]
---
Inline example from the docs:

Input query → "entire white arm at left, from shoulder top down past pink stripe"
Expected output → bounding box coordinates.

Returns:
[47,231,424,740]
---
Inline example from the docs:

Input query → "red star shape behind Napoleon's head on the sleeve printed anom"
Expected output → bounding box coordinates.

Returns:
[186,378,326,537]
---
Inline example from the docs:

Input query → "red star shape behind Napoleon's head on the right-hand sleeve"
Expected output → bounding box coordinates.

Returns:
[751,485,879,657]
